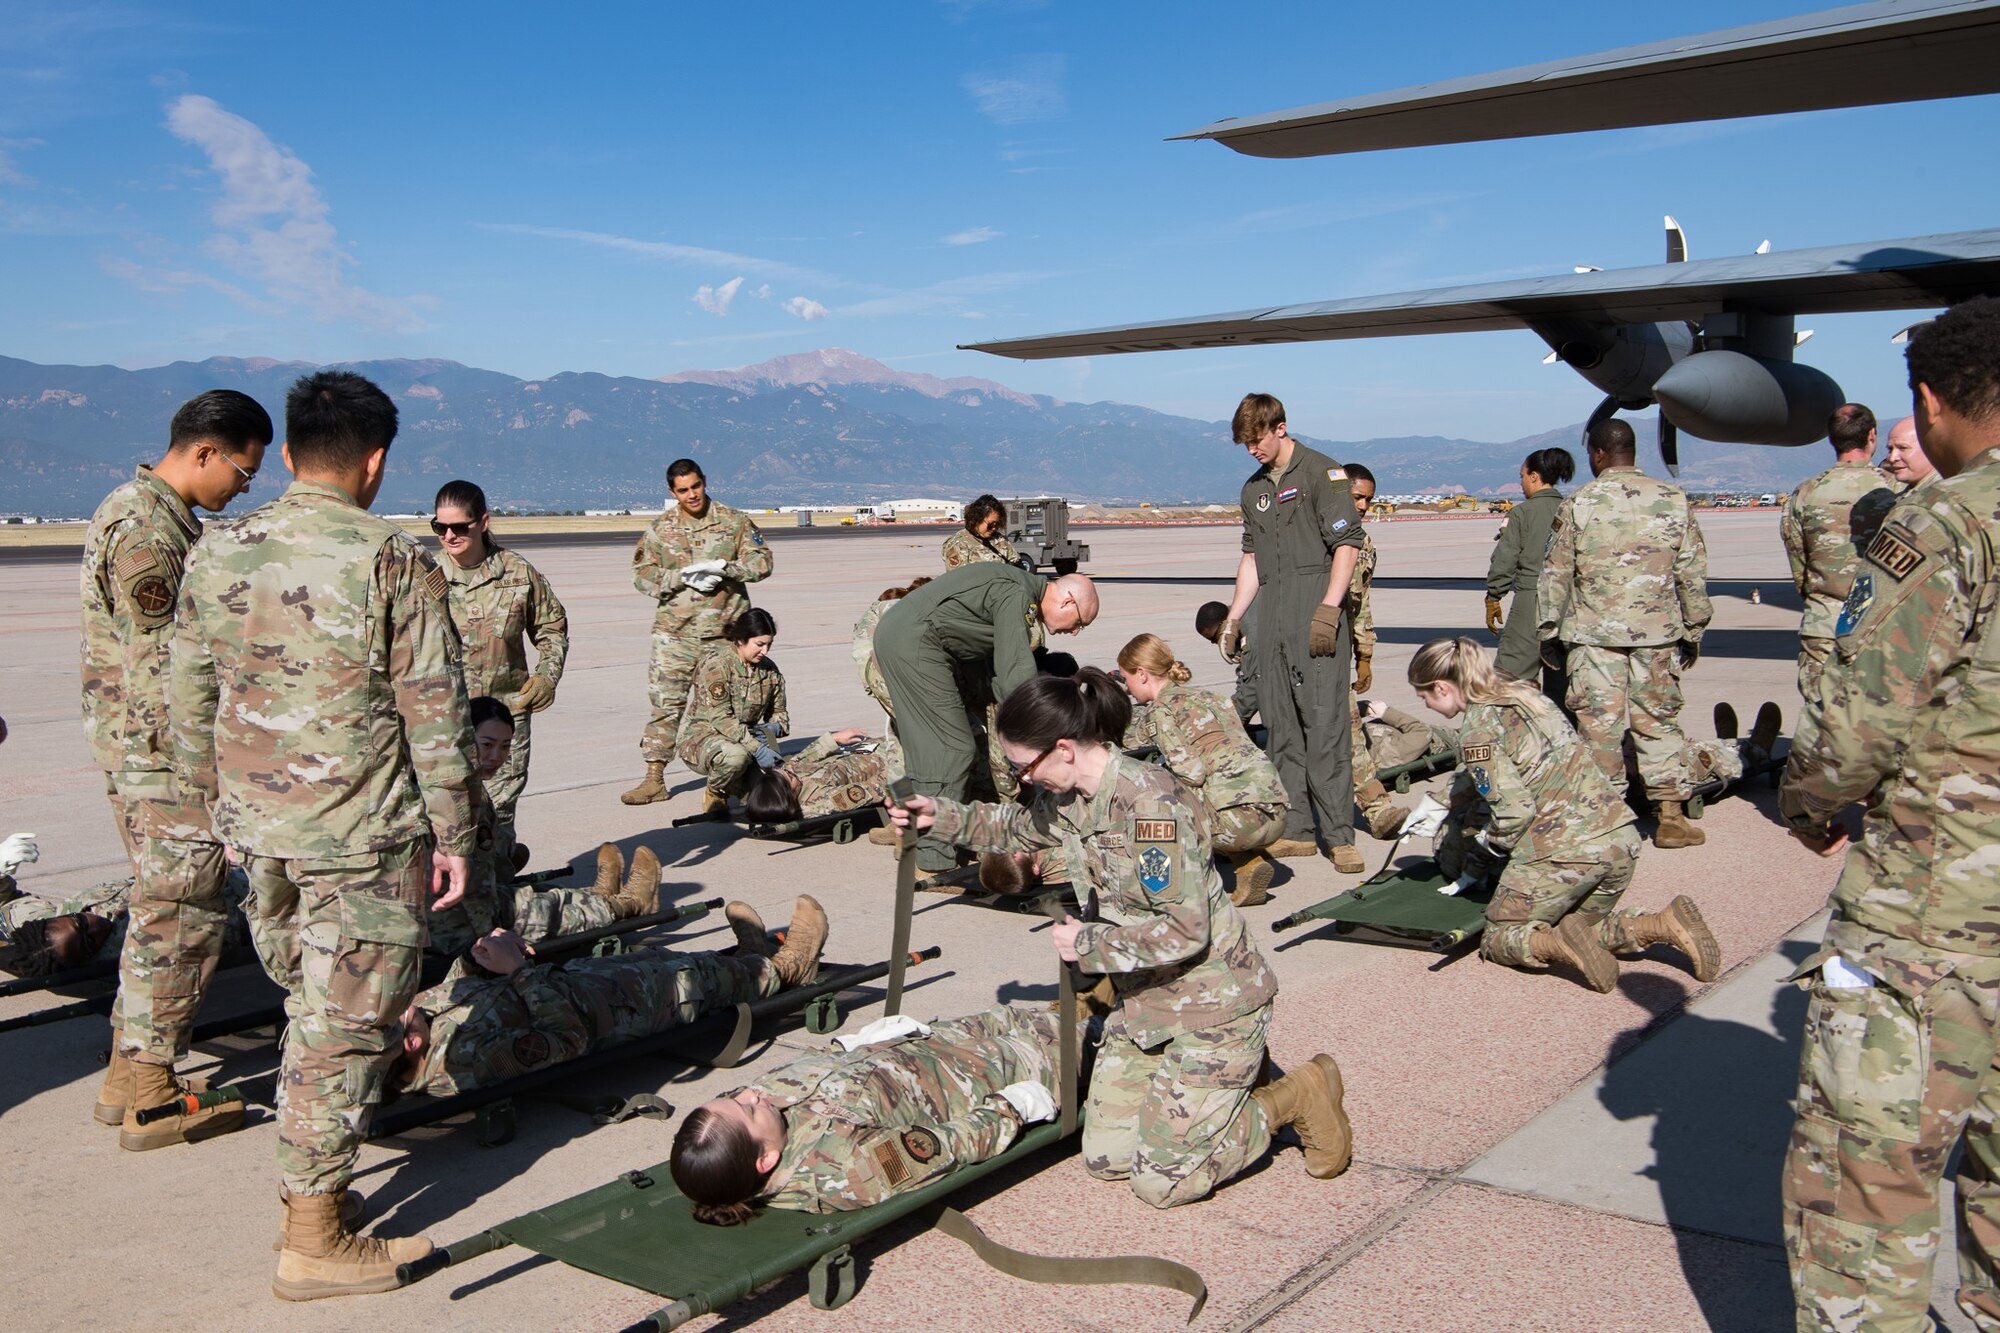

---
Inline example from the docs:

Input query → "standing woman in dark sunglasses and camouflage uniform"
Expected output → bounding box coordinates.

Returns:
[430,480,570,843]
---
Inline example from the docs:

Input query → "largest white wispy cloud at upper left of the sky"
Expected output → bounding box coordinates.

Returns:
[166,94,424,332]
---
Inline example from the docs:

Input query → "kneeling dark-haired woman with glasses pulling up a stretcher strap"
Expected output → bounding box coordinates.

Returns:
[890,667,1352,1209]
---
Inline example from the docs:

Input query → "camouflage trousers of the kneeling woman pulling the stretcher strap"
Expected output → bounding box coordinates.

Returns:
[1084,1005,1270,1209]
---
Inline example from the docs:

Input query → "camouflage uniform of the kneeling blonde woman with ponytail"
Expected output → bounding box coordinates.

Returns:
[1440,687,1642,969]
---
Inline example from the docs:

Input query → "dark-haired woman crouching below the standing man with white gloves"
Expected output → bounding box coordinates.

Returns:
[678,606,792,815]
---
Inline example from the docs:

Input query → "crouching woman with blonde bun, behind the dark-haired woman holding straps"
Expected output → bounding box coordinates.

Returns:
[1118,634,1286,907]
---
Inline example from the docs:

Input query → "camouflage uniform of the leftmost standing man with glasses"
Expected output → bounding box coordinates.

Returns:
[82,466,228,1065]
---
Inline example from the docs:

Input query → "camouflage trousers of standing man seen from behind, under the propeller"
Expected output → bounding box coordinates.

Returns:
[1568,642,1690,801]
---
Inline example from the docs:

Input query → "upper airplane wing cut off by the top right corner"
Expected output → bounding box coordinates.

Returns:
[1174,0,2000,158]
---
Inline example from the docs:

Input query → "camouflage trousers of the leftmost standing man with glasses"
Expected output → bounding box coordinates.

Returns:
[112,801,230,1065]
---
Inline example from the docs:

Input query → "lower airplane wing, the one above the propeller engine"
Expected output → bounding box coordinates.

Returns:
[960,228,2000,360]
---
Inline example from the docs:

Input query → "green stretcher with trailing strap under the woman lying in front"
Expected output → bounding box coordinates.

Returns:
[398,1125,1208,1333]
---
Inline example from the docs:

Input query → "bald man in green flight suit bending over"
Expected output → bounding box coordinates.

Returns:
[876,564,1098,873]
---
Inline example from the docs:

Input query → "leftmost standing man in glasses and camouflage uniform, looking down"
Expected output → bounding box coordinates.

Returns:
[82,388,272,1151]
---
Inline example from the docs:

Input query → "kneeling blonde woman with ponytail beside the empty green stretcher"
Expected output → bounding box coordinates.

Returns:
[1410,638,1722,991]
